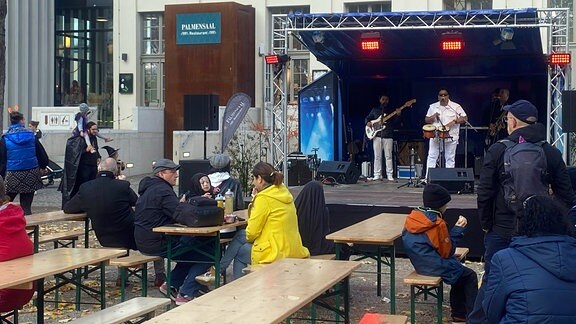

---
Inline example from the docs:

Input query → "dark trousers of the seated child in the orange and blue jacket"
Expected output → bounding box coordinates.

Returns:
[450,267,478,318]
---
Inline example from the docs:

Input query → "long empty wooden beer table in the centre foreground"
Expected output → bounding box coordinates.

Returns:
[147,259,360,324]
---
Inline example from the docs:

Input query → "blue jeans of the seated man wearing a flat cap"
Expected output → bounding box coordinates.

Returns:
[158,236,214,297]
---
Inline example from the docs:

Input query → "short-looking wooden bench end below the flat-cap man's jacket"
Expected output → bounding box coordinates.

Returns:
[110,252,162,301]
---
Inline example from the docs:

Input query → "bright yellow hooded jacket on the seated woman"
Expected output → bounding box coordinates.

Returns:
[246,185,310,264]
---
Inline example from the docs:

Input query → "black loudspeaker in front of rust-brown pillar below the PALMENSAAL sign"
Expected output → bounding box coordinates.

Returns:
[184,94,220,130]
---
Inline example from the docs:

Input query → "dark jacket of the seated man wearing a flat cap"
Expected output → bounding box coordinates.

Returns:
[134,176,180,255]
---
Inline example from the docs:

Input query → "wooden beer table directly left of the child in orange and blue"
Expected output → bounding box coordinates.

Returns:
[326,213,406,314]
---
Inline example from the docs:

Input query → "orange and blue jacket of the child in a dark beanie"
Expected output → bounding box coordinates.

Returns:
[402,209,464,284]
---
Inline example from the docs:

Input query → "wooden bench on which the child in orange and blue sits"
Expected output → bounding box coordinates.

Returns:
[404,247,470,324]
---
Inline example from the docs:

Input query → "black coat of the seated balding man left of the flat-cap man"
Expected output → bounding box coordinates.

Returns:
[64,171,138,250]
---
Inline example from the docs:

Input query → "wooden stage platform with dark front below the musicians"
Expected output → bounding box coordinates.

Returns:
[290,179,484,259]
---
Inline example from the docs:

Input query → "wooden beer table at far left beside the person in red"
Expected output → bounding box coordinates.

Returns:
[0,248,126,324]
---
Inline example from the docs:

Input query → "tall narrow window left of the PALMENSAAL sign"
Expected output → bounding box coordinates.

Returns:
[140,13,166,107]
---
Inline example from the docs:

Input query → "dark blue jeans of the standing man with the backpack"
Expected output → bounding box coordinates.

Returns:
[467,231,511,324]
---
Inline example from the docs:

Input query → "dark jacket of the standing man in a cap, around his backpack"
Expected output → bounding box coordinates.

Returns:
[478,123,576,238]
